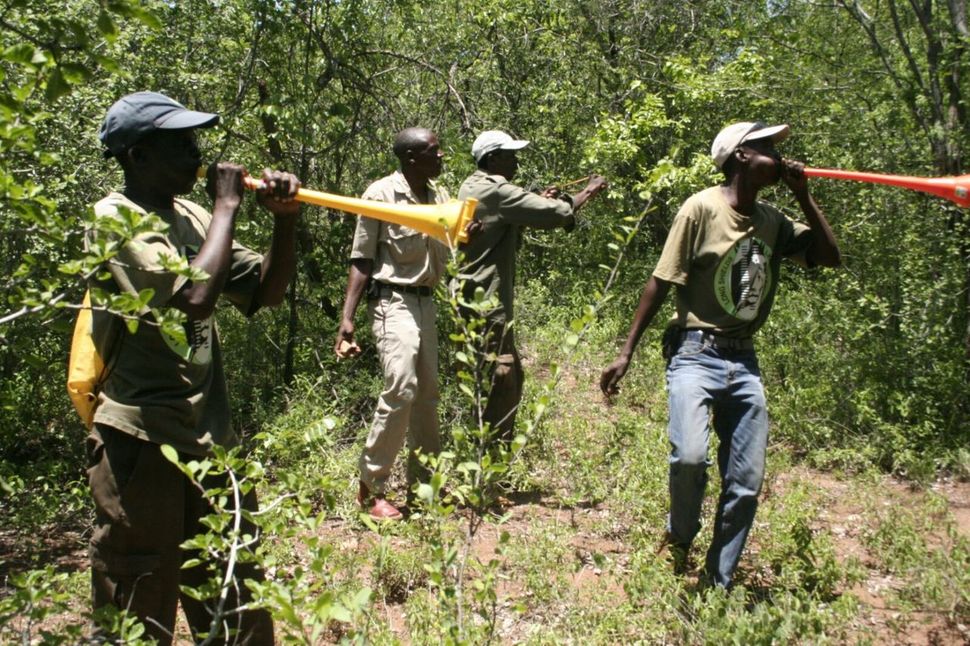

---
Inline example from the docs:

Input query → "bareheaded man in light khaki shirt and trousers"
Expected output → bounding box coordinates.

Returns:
[334,128,448,519]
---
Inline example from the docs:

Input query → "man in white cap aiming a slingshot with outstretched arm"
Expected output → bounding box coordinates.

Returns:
[457,130,606,442]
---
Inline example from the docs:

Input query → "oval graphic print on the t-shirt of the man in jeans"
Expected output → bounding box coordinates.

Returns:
[714,237,772,321]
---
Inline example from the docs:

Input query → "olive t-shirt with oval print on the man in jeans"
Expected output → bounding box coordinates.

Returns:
[653,186,812,338]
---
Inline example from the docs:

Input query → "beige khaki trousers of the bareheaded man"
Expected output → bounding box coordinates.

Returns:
[360,290,441,494]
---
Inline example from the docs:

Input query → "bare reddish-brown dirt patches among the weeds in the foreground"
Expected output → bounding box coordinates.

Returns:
[0,467,970,645]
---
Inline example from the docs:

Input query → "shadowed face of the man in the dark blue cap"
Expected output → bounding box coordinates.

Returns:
[131,129,202,195]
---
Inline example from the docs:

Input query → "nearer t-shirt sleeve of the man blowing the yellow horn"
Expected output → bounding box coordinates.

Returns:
[96,201,188,314]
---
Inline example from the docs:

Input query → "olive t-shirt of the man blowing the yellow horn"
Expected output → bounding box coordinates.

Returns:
[88,193,262,455]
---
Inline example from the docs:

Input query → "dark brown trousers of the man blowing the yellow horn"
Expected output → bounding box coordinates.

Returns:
[87,424,274,646]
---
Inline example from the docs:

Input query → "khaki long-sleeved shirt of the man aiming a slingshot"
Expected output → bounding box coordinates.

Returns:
[458,170,573,322]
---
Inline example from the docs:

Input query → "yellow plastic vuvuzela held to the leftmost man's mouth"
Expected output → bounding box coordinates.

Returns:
[199,167,478,246]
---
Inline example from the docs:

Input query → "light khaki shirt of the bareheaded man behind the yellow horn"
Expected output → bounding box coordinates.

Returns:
[350,171,448,288]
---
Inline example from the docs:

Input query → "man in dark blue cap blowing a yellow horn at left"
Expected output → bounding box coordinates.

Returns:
[87,92,299,645]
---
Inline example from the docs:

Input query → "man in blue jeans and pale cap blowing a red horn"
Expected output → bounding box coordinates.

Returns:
[600,122,841,587]
